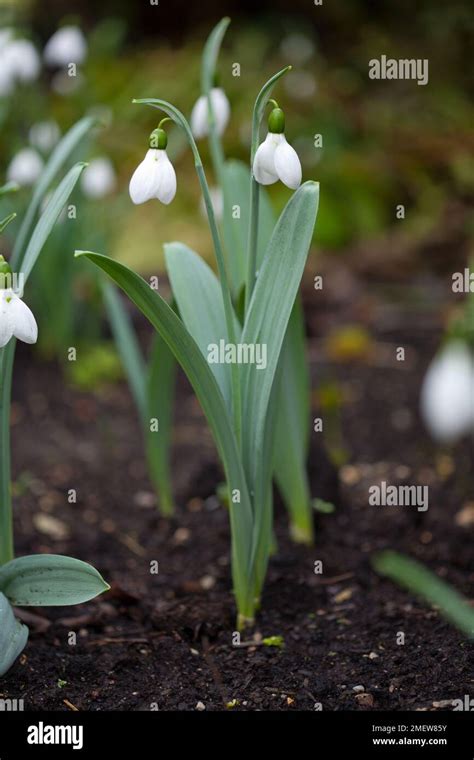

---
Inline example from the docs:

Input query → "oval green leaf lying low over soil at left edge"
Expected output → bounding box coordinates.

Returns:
[0,554,110,607]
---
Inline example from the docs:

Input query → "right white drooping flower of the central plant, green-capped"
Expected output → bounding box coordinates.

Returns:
[253,107,302,190]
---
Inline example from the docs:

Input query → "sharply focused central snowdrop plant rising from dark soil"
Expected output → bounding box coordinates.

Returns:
[76,19,319,627]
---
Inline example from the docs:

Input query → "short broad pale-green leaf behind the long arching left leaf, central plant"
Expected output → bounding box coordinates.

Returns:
[165,243,240,409]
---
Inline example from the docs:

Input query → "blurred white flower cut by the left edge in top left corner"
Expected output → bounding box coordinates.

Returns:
[0,29,41,96]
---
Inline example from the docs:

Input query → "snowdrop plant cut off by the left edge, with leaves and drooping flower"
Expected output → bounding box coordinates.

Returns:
[0,124,108,676]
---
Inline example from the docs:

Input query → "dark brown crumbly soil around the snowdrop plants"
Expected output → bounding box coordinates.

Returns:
[0,264,474,710]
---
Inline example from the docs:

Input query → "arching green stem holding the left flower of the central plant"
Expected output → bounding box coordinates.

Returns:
[133,98,242,443]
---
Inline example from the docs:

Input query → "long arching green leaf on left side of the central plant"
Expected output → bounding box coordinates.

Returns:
[76,251,252,607]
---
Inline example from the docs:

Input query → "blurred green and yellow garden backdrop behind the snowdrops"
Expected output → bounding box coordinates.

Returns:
[0,0,474,388]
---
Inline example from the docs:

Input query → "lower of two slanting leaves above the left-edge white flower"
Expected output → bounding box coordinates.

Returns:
[16,164,86,282]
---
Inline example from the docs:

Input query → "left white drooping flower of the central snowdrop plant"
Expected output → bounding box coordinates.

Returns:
[129,127,176,205]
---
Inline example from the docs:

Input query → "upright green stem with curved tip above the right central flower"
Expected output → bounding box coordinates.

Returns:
[245,66,291,313]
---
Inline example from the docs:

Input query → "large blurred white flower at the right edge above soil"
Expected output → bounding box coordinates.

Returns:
[421,340,474,443]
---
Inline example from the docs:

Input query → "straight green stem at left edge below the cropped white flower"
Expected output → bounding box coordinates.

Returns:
[0,338,15,565]
